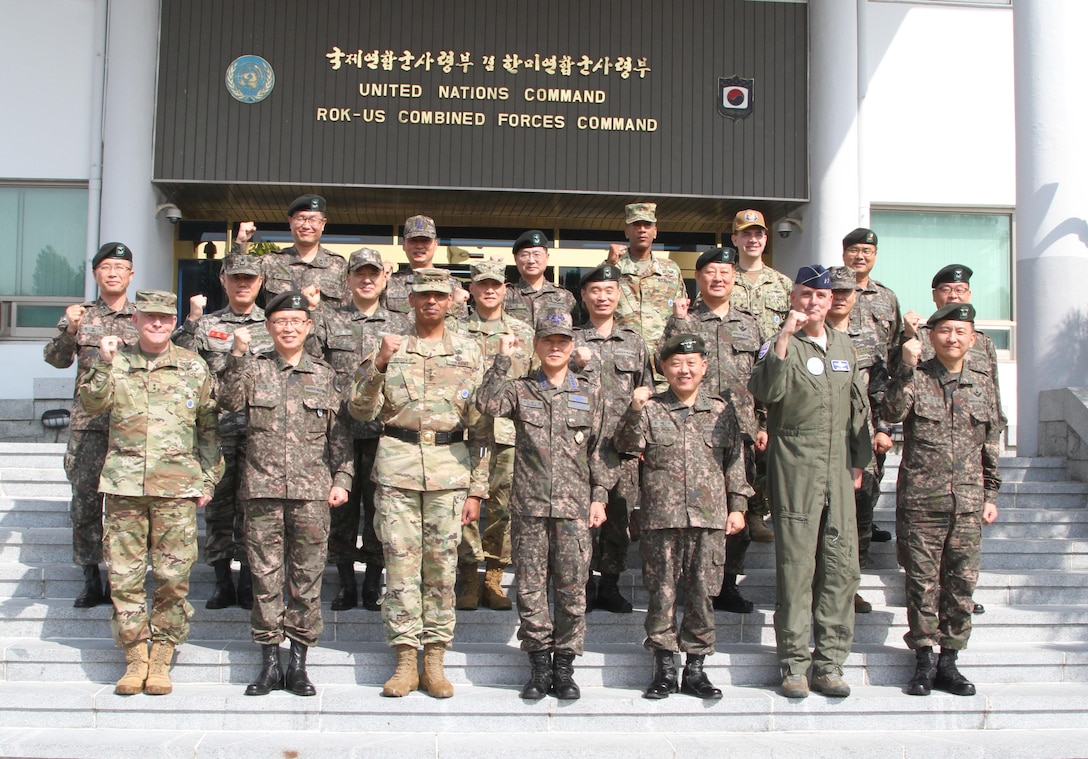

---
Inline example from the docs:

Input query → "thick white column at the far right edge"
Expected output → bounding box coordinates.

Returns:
[1013,0,1088,456]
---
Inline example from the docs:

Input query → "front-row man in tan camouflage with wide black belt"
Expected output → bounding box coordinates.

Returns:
[349,269,491,698]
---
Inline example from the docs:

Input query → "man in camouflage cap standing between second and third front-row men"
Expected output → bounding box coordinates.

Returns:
[316,248,411,611]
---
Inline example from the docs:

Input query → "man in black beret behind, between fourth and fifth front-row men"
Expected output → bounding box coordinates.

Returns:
[573,263,654,614]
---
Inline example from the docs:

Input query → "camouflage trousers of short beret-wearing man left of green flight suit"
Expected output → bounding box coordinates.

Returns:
[639,527,726,656]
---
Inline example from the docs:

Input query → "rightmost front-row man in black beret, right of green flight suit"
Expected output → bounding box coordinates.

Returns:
[885,303,1001,696]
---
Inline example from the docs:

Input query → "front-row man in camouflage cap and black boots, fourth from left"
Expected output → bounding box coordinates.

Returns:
[477,310,615,700]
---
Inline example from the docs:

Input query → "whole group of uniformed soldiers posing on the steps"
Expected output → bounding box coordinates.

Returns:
[46,195,1003,699]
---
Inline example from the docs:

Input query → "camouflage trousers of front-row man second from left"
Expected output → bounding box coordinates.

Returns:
[245,498,330,646]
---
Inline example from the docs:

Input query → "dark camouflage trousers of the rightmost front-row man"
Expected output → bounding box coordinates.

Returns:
[895,509,982,649]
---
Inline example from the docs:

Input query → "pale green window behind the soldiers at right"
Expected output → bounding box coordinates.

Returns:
[869,210,1014,358]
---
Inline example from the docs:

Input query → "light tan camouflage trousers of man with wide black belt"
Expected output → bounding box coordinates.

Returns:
[375,485,466,647]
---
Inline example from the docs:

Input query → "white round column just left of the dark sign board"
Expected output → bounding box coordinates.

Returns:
[99,0,174,291]
